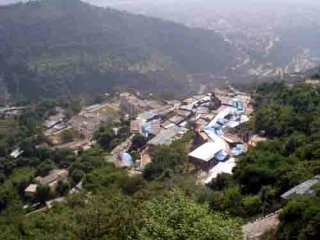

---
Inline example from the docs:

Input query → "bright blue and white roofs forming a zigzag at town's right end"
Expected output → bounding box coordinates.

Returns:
[189,88,253,184]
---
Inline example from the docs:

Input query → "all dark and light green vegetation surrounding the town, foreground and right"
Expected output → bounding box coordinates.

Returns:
[0,79,320,240]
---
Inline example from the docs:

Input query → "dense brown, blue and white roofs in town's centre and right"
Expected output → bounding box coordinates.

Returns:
[112,87,253,178]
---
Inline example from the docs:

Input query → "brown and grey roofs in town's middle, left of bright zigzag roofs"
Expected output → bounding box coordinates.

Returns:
[111,93,191,171]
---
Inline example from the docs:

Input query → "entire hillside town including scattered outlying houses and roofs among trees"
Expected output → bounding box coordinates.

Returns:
[0,82,320,239]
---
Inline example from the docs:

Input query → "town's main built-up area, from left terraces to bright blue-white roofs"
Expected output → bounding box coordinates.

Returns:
[11,86,256,188]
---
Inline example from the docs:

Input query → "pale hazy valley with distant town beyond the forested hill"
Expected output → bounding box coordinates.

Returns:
[95,0,320,81]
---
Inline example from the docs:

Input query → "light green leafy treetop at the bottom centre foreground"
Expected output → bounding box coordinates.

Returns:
[139,191,242,240]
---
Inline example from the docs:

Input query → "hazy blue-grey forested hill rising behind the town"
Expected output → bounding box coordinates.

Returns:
[0,0,235,100]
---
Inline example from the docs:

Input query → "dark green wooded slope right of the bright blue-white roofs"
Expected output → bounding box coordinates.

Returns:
[202,82,320,239]
